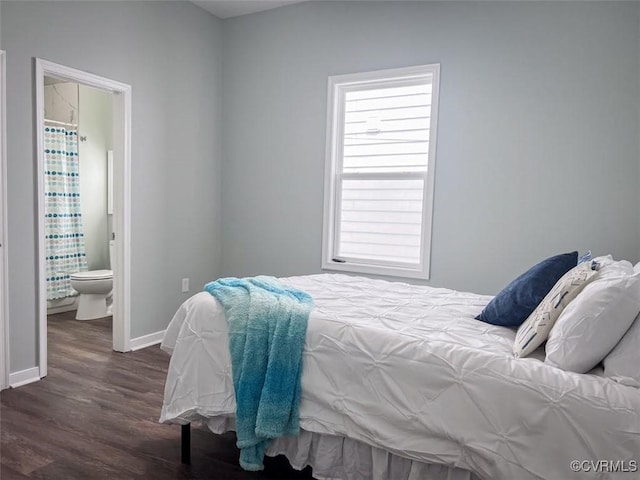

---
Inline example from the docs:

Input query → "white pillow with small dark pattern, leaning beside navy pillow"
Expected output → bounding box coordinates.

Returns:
[513,261,596,357]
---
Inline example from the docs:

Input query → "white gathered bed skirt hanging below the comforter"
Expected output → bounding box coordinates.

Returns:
[203,416,481,480]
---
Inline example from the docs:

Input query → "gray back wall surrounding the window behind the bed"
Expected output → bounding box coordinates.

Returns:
[222,2,640,293]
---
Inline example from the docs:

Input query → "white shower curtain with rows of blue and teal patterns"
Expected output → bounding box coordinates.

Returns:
[44,127,87,300]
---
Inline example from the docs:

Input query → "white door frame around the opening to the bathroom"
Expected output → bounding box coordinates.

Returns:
[35,58,131,377]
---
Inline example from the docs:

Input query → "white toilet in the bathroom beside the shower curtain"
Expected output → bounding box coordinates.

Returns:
[69,240,114,320]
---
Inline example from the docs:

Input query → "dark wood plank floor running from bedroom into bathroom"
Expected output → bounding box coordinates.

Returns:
[0,312,312,480]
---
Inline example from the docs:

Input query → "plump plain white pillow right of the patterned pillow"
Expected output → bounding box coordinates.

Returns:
[545,260,640,373]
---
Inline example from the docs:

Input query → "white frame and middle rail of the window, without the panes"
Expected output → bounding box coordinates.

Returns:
[322,63,440,280]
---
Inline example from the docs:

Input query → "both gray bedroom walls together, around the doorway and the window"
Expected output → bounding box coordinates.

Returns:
[0,0,640,372]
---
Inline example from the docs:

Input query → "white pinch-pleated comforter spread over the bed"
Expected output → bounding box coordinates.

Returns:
[160,274,640,480]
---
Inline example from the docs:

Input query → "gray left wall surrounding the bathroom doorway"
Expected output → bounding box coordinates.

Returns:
[0,0,222,372]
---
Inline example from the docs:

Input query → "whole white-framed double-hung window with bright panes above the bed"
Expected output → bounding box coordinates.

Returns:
[322,64,440,278]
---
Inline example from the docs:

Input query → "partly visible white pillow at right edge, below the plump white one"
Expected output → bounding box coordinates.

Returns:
[604,314,640,387]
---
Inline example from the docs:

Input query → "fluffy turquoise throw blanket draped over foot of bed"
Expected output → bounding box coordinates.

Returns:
[204,276,313,470]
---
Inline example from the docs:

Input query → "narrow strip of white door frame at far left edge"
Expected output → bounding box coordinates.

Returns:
[0,50,10,390]
